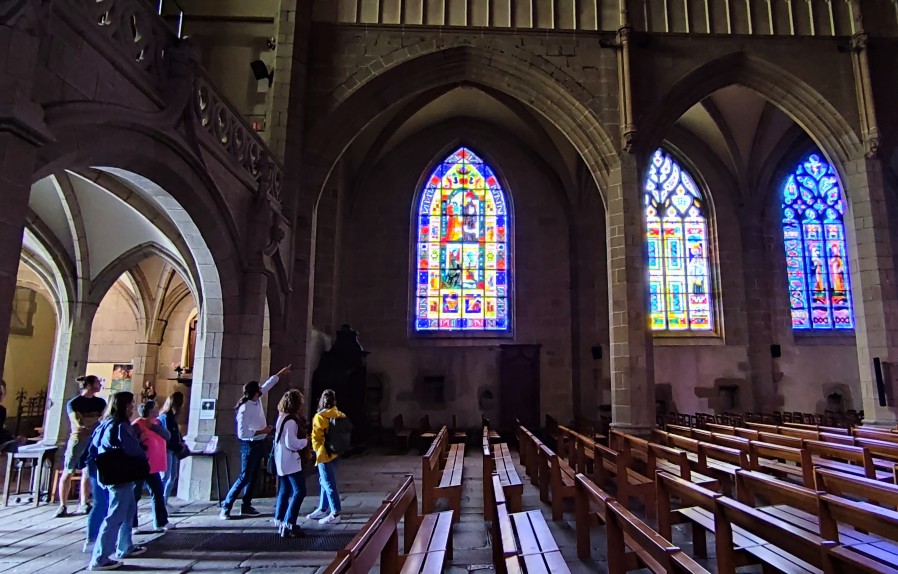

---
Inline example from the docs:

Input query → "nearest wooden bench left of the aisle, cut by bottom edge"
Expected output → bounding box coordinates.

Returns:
[325,475,453,574]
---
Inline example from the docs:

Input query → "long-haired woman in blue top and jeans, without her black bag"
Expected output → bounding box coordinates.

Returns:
[88,391,147,570]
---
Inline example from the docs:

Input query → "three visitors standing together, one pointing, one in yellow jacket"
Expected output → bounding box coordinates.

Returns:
[219,365,346,538]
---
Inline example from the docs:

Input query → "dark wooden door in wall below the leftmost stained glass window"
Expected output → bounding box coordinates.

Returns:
[499,345,540,429]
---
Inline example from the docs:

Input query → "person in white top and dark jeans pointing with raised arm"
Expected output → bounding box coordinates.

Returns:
[219,365,292,520]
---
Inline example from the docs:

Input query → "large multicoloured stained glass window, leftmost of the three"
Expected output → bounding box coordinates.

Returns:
[415,147,511,331]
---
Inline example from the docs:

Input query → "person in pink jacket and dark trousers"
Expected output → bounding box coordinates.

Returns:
[131,400,172,530]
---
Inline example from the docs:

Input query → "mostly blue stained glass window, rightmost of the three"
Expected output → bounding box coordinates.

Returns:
[782,153,854,330]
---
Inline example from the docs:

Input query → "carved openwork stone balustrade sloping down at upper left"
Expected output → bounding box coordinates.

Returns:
[69,0,284,201]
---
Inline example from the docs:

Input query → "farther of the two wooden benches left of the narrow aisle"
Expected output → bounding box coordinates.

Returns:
[421,426,465,521]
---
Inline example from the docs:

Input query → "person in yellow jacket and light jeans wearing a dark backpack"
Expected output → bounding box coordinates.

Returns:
[306,389,346,524]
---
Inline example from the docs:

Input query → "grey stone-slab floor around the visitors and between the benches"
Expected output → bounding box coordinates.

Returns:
[0,447,606,574]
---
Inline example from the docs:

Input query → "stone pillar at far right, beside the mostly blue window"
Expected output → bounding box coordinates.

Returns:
[845,157,898,427]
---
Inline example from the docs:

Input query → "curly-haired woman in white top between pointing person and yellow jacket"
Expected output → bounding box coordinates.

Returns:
[272,389,309,538]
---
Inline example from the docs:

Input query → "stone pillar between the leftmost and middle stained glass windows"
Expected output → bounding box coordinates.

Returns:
[607,153,655,434]
